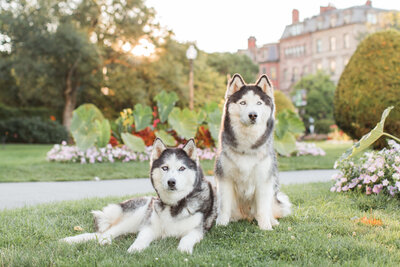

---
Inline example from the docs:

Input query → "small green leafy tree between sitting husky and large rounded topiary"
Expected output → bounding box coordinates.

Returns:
[294,72,335,133]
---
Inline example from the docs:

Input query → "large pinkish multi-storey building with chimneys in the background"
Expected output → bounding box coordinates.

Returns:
[239,1,398,94]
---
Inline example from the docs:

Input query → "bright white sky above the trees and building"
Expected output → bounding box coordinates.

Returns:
[146,0,400,53]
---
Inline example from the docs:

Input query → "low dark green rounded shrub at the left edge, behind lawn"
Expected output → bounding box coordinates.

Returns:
[0,117,68,144]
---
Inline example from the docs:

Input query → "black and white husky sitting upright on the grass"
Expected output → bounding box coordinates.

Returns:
[215,74,291,230]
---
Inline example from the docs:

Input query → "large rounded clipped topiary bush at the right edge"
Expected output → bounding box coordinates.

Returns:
[335,30,400,147]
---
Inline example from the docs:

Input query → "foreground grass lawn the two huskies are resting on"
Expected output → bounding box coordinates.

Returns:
[0,183,400,266]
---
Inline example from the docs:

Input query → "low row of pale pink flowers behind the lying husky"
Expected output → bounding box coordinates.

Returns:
[47,141,216,164]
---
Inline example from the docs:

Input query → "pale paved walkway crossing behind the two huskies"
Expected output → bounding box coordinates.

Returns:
[0,170,337,210]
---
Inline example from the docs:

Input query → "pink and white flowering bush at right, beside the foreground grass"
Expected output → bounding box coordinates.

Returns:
[331,140,400,196]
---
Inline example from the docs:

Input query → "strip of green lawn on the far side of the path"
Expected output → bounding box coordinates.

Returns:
[0,142,350,182]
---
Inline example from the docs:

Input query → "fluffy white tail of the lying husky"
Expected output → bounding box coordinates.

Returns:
[92,204,123,233]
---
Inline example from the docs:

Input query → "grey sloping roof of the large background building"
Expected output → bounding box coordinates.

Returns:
[281,5,390,39]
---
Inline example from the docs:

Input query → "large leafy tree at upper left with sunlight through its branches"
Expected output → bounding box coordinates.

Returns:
[0,0,157,129]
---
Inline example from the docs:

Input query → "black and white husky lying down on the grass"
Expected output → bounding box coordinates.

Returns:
[61,139,217,253]
